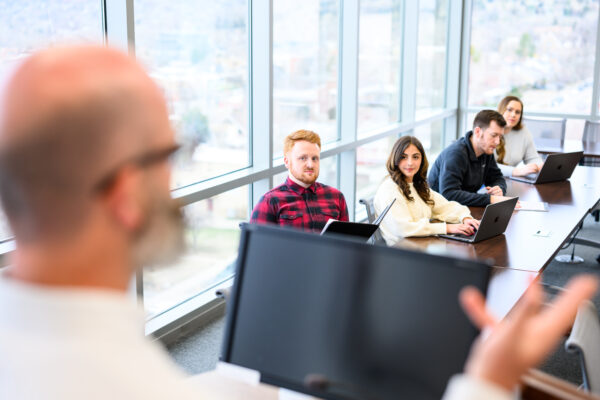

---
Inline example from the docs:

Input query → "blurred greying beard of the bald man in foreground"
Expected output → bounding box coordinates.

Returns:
[133,190,185,267]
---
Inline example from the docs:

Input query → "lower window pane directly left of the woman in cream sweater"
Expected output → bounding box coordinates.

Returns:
[356,135,397,211]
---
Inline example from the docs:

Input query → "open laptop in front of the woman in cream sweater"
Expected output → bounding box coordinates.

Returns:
[439,197,519,243]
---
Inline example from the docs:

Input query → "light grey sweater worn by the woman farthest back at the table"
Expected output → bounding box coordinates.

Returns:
[494,126,542,176]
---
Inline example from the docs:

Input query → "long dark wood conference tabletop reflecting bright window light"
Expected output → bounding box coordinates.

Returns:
[397,166,600,272]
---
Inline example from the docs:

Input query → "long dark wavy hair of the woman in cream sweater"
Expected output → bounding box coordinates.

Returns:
[386,136,433,205]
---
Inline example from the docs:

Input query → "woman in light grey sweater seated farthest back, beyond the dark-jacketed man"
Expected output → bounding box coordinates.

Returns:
[494,96,542,176]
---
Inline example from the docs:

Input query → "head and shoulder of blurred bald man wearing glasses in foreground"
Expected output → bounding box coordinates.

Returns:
[0,47,198,400]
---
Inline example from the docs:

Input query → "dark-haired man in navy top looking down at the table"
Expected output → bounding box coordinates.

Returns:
[429,110,506,207]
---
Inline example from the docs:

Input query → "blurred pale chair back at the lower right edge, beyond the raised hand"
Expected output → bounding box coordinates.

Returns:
[565,301,600,394]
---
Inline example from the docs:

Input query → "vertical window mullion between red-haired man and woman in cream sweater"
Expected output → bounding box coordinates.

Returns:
[337,0,360,220]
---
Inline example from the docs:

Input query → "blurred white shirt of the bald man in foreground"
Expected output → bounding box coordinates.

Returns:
[0,274,200,400]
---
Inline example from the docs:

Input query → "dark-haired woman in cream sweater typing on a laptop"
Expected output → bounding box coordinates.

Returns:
[373,136,479,245]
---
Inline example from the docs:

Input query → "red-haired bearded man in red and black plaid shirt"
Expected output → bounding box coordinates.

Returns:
[250,130,348,232]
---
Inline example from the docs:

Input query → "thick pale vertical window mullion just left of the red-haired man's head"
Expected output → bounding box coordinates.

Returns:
[249,0,273,209]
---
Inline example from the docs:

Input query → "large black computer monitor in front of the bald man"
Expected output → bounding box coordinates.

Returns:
[221,225,489,400]
